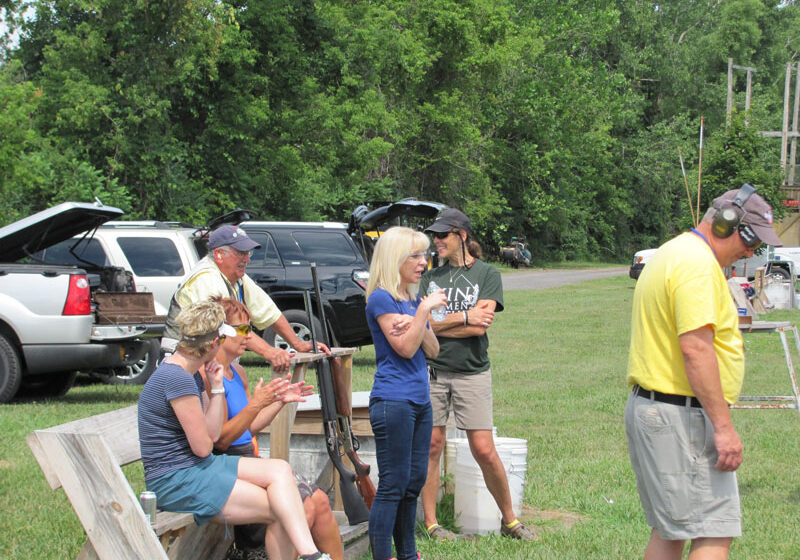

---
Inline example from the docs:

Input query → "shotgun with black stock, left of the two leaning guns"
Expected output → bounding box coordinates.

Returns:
[303,286,369,525]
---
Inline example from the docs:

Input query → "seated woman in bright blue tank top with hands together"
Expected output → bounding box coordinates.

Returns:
[201,297,344,560]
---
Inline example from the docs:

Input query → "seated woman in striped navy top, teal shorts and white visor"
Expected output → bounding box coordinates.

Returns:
[138,301,330,560]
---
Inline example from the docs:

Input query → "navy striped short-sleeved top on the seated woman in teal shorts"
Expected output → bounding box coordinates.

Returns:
[139,362,205,481]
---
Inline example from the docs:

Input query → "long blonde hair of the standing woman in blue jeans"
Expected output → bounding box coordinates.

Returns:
[367,226,430,300]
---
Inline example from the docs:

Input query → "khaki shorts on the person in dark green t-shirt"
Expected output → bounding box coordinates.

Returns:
[431,369,494,430]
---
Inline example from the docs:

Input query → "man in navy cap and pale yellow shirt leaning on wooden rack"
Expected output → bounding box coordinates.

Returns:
[161,225,328,373]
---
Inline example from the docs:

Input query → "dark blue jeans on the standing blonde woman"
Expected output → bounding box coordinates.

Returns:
[369,399,433,560]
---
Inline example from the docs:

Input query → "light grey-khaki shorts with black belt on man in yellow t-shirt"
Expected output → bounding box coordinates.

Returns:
[625,393,742,540]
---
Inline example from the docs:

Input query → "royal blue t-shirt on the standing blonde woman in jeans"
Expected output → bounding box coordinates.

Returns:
[367,288,430,404]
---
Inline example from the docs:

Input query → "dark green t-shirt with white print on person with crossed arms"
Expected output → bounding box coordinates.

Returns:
[419,260,503,374]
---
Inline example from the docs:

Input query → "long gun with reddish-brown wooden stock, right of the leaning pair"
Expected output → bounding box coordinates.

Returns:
[311,263,375,508]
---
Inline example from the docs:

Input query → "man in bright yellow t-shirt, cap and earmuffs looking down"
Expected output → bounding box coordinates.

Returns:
[625,185,782,560]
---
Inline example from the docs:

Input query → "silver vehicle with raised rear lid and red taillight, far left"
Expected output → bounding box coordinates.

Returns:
[0,202,149,402]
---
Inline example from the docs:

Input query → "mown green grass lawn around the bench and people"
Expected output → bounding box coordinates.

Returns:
[0,277,800,560]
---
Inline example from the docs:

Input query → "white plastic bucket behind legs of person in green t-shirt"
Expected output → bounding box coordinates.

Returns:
[454,438,528,535]
